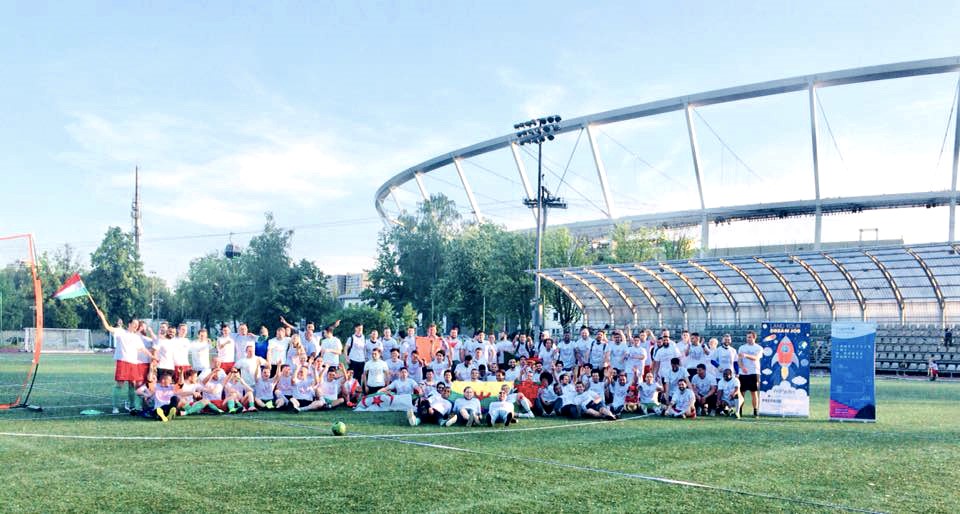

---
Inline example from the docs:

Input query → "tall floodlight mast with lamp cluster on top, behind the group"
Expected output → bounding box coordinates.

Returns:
[513,115,567,340]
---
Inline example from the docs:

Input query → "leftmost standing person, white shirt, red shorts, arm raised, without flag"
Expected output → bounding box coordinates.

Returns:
[95,307,153,414]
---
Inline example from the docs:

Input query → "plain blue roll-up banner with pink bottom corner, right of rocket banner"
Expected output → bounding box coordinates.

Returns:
[830,322,877,421]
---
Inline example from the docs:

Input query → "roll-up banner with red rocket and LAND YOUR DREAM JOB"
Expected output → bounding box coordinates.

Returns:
[760,321,810,417]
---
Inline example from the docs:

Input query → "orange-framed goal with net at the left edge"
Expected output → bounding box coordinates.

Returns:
[0,234,44,410]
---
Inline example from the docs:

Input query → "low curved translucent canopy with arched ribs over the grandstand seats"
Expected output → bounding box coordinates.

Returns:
[530,243,960,327]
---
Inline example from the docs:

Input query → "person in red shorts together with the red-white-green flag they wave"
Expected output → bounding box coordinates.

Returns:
[53,273,153,414]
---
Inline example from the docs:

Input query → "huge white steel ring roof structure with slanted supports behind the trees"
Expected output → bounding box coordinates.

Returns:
[374,56,960,248]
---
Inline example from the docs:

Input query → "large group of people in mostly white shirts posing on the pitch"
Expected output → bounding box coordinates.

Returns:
[98,304,762,426]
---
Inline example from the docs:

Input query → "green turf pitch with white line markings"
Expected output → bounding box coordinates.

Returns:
[0,354,960,512]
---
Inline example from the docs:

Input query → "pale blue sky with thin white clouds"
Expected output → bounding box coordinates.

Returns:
[0,1,960,284]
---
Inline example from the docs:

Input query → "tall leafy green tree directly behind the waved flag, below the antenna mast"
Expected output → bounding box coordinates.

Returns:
[84,227,149,328]
